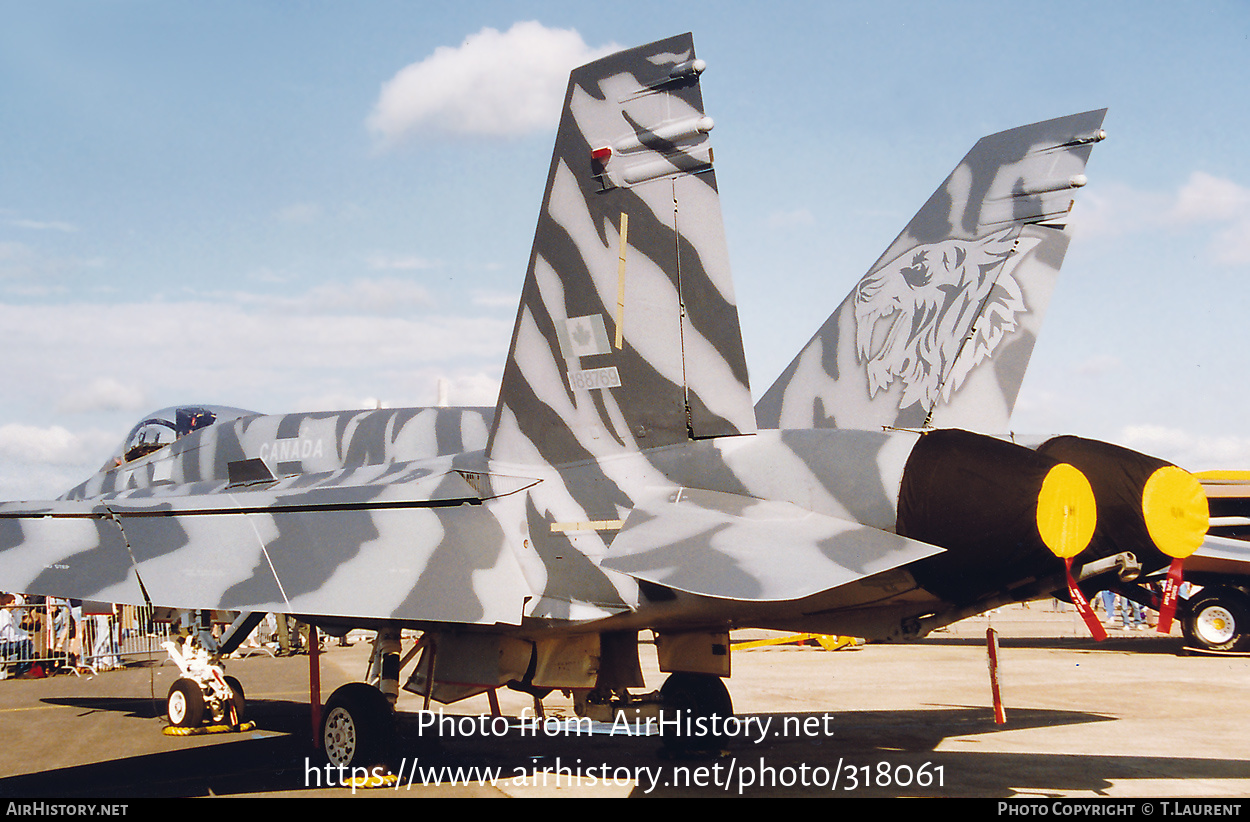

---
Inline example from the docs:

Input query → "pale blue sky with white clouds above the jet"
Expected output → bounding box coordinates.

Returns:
[0,0,1250,498]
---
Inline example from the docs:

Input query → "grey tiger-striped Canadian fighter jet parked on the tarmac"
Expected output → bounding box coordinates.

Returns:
[0,35,1206,765]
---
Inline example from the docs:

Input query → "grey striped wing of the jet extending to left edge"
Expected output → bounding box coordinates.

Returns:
[0,461,530,625]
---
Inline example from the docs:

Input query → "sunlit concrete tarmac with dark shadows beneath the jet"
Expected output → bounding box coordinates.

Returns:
[0,603,1250,798]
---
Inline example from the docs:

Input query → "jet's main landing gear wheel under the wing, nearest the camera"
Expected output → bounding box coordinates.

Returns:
[321,682,395,772]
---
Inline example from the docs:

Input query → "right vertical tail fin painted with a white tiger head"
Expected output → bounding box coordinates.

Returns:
[756,109,1106,432]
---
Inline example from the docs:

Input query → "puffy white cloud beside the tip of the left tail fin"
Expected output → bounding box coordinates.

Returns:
[368,21,619,146]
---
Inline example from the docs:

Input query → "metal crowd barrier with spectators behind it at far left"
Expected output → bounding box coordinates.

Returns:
[0,598,170,680]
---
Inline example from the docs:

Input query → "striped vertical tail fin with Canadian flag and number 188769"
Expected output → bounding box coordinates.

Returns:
[488,34,755,465]
